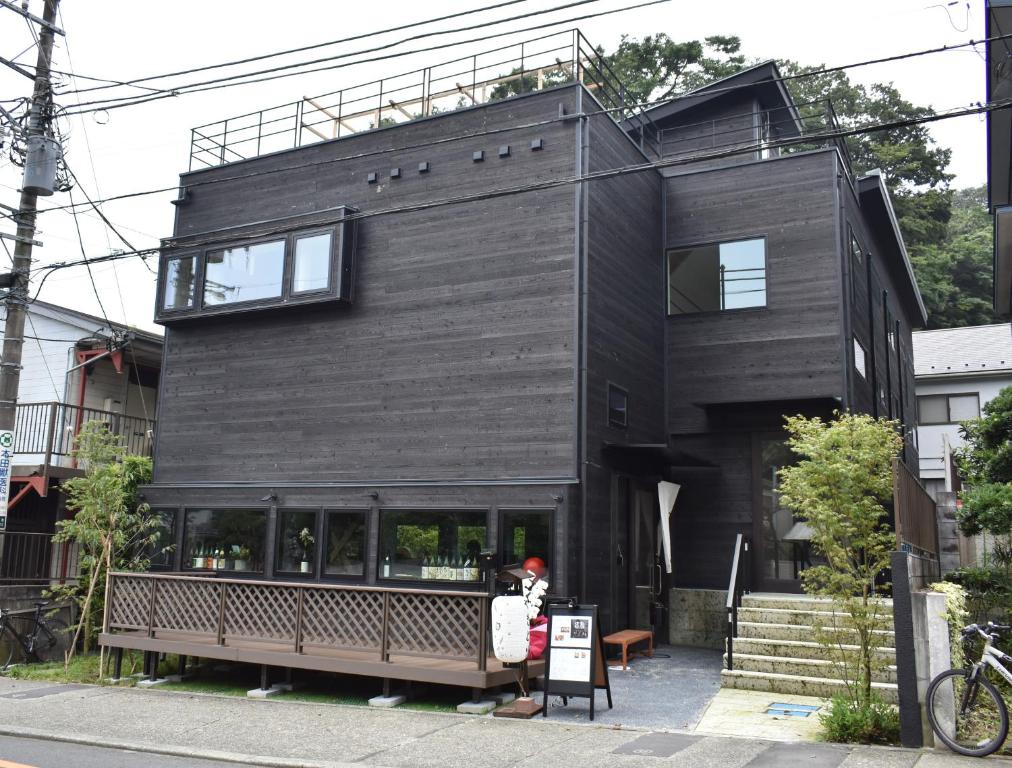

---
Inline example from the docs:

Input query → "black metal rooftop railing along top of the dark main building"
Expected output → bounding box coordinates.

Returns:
[189,29,657,170]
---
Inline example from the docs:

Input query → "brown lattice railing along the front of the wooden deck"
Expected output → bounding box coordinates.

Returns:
[103,573,489,671]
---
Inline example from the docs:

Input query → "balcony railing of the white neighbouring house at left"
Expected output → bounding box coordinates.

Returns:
[14,402,155,467]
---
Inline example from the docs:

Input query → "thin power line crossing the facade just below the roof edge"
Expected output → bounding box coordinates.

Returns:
[38,33,1012,214]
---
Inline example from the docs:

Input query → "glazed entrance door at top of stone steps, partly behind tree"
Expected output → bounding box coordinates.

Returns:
[752,435,811,592]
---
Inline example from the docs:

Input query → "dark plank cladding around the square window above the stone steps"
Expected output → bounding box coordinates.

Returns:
[666,152,846,433]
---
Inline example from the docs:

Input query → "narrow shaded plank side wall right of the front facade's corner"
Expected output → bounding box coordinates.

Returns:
[583,102,667,631]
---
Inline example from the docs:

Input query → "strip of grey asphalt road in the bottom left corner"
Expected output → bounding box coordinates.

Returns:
[0,736,244,768]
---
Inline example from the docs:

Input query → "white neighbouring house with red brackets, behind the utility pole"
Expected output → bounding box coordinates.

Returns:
[0,301,162,582]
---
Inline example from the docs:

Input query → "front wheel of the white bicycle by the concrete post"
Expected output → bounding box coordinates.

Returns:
[925,669,1009,757]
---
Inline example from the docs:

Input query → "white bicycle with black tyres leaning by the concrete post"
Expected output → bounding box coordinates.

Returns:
[924,621,1012,757]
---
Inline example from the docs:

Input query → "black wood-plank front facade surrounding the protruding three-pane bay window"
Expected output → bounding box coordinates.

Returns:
[155,88,576,483]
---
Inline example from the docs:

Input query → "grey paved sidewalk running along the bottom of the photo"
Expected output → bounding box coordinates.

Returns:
[0,679,1012,768]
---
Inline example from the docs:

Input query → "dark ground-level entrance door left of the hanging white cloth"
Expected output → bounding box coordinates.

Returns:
[629,485,667,637]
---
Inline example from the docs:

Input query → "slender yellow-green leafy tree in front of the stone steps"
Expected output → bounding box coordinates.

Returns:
[780,413,903,707]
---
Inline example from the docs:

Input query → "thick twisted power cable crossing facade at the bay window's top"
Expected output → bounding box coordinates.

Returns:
[36,93,1012,279]
